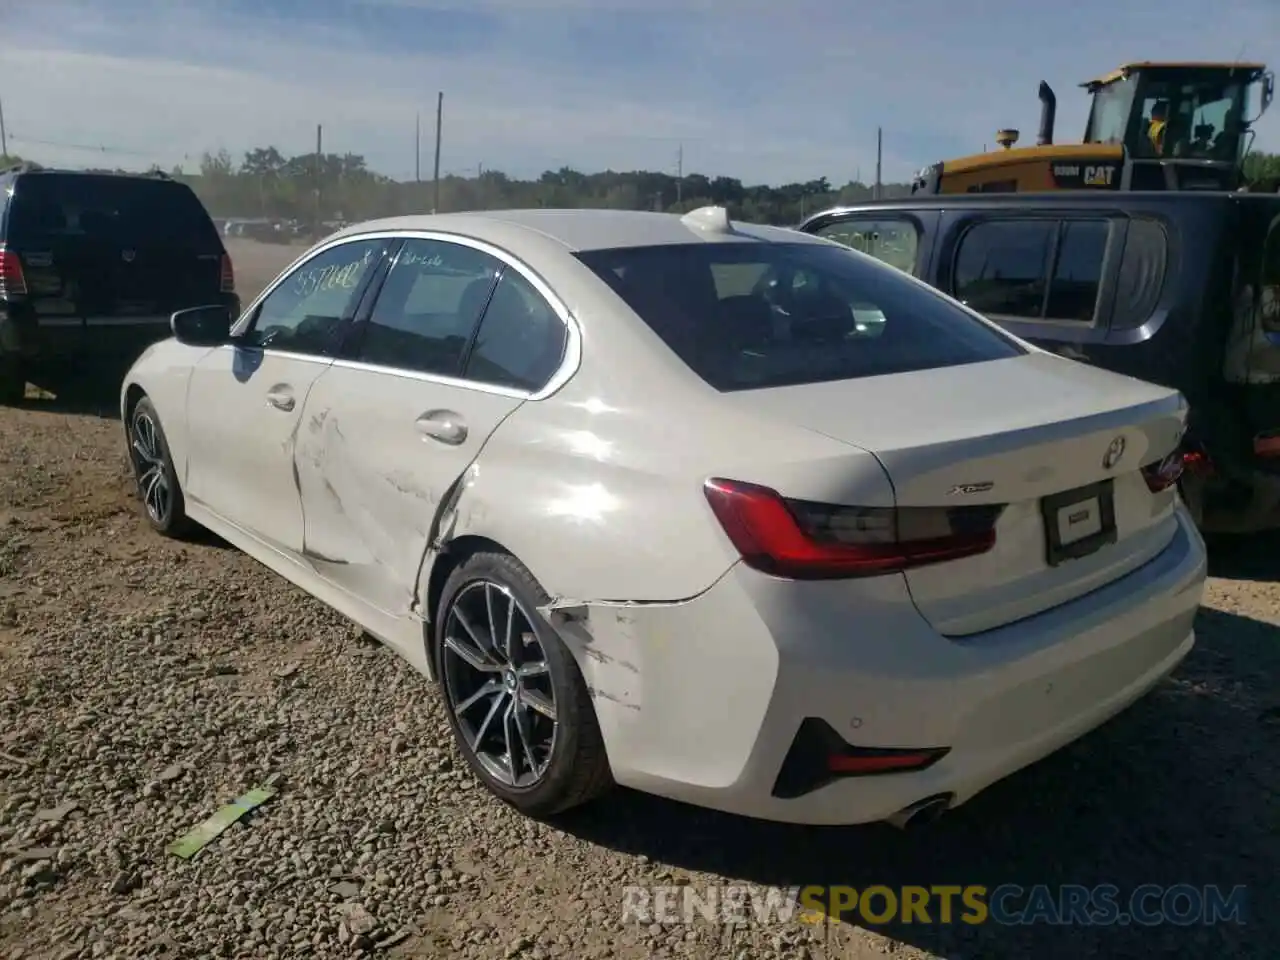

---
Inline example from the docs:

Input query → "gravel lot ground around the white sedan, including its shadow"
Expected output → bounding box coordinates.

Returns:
[0,251,1280,960]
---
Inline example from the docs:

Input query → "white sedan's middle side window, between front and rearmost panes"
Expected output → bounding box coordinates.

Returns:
[357,239,500,376]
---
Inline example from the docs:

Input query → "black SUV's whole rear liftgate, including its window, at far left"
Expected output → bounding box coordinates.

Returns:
[6,173,224,323]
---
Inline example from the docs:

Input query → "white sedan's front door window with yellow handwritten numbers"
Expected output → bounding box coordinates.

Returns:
[244,239,387,353]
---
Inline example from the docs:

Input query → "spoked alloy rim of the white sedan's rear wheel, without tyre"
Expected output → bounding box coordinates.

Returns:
[442,580,558,790]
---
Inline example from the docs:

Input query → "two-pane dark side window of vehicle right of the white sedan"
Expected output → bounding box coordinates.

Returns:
[952,220,1110,324]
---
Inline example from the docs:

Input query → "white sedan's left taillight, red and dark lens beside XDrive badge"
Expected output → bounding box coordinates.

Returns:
[704,477,1004,580]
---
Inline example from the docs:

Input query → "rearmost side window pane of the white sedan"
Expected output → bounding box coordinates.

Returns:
[466,268,568,392]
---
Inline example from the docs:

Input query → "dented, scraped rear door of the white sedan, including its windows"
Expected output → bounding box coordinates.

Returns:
[297,237,567,616]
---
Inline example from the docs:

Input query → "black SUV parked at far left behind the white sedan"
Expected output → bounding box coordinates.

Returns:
[0,164,239,403]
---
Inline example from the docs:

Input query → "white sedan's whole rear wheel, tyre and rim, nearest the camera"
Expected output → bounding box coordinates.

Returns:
[435,553,612,817]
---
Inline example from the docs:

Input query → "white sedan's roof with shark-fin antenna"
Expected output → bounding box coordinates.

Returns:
[334,207,813,253]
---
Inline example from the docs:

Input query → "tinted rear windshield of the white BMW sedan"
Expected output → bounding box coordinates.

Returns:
[577,242,1025,390]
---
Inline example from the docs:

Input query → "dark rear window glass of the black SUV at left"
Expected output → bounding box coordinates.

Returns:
[8,173,221,251]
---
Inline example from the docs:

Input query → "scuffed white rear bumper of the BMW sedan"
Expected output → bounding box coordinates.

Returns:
[576,507,1206,824]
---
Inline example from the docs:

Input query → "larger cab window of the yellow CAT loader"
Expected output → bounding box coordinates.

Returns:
[1131,70,1249,163]
